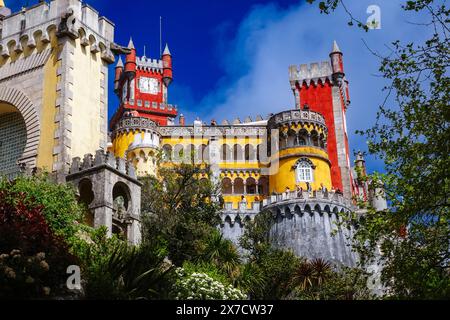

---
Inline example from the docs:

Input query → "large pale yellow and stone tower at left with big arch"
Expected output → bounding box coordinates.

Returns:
[0,0,117,181]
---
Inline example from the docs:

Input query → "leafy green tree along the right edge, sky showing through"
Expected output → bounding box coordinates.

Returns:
[310,0,450,299]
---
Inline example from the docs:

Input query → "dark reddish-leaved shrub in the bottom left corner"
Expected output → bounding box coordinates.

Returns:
[0,189,76,299]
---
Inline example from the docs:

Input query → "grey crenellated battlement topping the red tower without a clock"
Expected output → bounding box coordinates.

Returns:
[289,61,333,88]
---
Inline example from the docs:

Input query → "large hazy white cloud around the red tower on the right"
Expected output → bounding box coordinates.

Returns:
[188,1,430,170]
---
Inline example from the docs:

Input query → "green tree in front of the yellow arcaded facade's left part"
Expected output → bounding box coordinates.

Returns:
[142,164,220,266]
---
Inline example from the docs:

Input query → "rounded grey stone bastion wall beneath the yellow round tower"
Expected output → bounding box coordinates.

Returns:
[220,191,357,266]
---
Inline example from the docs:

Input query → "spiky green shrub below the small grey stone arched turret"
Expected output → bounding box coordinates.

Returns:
[74,227,173,299]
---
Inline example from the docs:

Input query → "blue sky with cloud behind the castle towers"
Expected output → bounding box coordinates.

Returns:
[6,0,426,171]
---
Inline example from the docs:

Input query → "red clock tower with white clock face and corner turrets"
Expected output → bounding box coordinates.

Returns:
[110,39,177,128]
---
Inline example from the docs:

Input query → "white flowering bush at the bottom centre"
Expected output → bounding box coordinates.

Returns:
[175,268,247,300]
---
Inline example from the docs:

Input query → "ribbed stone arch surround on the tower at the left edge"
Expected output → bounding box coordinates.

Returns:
[0,87,40,168]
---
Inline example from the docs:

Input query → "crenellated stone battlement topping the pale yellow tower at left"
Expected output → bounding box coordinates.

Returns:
[0,0,114,63]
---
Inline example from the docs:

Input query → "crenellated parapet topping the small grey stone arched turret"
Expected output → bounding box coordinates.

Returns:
[69,150,136,180]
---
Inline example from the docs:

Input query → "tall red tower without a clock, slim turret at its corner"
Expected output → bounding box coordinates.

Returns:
[289,41,353,198]
